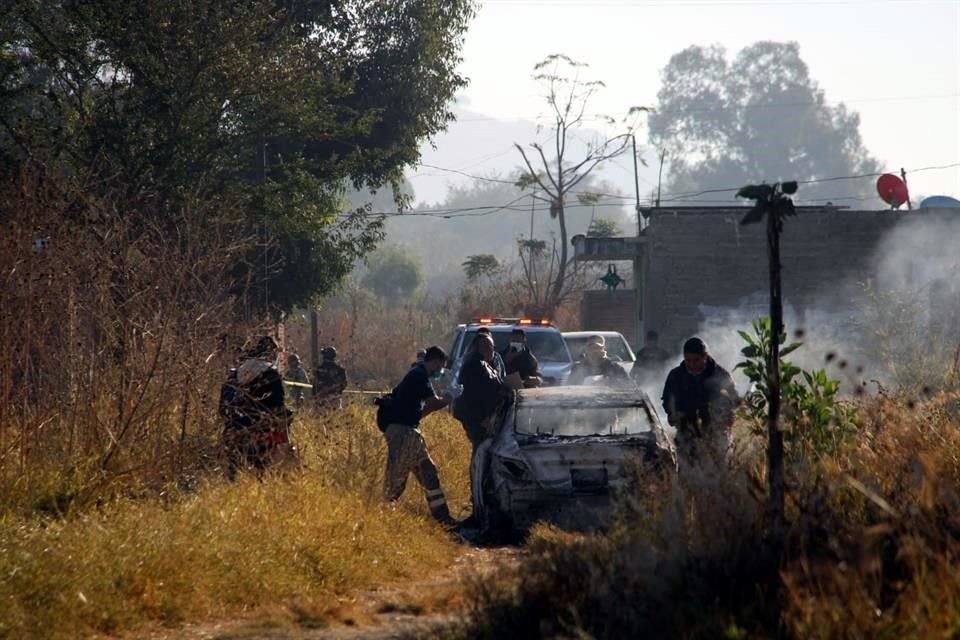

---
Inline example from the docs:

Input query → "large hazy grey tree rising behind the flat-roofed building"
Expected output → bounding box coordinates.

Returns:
[650,42,878,202]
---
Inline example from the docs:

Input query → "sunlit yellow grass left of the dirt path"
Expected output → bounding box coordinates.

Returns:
[0,406,469,638]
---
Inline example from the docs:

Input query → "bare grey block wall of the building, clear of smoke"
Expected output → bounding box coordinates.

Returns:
[636,208,960,348]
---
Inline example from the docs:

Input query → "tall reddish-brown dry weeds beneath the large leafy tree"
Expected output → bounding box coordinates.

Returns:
[0,166,255,511]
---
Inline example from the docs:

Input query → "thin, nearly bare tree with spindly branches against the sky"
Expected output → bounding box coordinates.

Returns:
[514,54,648,314]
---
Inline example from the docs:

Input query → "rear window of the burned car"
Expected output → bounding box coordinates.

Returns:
[513,402,656,438]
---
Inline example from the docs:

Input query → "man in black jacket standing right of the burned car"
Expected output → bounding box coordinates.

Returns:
[663,337,737,463]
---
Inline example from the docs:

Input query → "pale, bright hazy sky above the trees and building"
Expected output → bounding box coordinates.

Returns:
[422,0,960,205]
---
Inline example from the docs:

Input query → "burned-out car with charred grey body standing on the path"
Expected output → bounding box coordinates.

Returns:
[470,386,676,533]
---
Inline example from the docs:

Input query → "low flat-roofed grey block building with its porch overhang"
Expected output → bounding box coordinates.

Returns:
[573,207,960,348]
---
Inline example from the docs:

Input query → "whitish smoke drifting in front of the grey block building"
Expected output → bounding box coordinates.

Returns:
[640,213,960,404]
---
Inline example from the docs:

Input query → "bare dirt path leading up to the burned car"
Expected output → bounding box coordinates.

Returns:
[138,545,523,640]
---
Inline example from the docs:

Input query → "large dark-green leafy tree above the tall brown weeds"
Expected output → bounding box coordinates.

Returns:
[0,0,473,308]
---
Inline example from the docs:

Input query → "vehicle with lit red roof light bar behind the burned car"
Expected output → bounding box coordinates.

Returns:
[444,318,573,397]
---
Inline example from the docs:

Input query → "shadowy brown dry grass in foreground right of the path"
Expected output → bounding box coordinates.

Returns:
[462,394,960,638]
